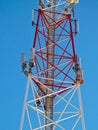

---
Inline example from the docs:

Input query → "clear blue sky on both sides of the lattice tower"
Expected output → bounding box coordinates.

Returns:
[0,0,98,130]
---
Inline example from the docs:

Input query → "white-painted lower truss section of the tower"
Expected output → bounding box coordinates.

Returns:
[20,74,85,130]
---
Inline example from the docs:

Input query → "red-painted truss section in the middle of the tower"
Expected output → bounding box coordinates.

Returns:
[33,10,76,85]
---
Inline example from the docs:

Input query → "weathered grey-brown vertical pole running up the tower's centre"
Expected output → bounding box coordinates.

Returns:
[45,0,55,130]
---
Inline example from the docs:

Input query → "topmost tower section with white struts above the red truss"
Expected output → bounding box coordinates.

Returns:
[36,0,79,17]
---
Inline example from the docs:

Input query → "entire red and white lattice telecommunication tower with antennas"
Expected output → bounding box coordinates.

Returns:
[20,0,86,130]
